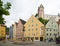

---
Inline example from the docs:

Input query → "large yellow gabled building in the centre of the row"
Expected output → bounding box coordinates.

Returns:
[24,15,44,41]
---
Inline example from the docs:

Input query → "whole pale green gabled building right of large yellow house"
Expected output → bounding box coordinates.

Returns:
[45,17,58,41]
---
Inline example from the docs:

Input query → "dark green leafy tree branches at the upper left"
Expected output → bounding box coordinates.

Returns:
[0,0,11,24]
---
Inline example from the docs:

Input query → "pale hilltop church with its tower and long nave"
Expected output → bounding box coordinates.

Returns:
[37,4,60,21]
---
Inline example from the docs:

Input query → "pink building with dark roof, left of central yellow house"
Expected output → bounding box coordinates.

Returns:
[16,19,26,40]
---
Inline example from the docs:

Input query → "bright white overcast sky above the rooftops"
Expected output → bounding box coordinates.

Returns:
[3,0,60,27]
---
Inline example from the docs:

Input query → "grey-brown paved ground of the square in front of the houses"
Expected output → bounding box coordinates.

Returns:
[0,41,60,46]
